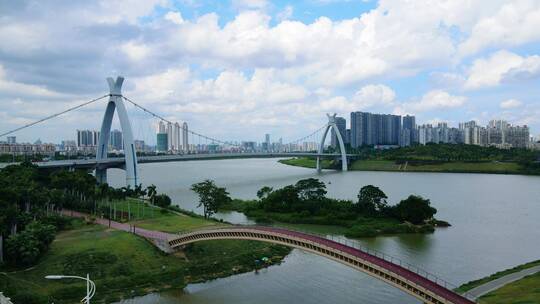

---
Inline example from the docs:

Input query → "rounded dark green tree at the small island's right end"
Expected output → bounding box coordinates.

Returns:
[394,195,437,225]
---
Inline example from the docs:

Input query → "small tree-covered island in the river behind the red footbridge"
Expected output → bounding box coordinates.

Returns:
[220,178,449,238]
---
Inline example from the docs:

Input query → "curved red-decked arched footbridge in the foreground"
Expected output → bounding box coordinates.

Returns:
[168,226,474,304]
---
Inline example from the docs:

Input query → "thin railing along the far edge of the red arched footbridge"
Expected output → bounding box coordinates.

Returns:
[173,224,475,300]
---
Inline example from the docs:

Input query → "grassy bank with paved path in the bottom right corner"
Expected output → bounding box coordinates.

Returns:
[456,260,540,304]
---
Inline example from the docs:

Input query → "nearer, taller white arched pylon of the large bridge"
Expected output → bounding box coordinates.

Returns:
[96,76,138,188]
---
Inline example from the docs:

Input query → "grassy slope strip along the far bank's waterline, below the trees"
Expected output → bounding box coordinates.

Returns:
[279,158,531,175]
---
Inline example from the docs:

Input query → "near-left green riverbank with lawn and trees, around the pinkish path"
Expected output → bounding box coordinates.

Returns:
[0,163,290,304]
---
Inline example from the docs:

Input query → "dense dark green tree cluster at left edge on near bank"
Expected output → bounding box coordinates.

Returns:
[0,162,171,266]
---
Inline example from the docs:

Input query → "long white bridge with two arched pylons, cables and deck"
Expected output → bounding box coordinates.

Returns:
[0,76,354,187]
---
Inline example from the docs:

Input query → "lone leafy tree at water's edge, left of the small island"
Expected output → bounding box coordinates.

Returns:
[191,179,232,218]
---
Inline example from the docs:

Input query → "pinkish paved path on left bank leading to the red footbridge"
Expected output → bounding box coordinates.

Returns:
[62,209,176,252]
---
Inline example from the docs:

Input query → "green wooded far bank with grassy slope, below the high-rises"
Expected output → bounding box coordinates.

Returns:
[280,143,540,175]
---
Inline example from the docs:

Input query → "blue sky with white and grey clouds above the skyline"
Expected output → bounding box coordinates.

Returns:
[0,0,540,142]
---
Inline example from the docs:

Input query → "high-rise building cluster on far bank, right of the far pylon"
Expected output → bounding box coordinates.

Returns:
[331,112,536,148]
